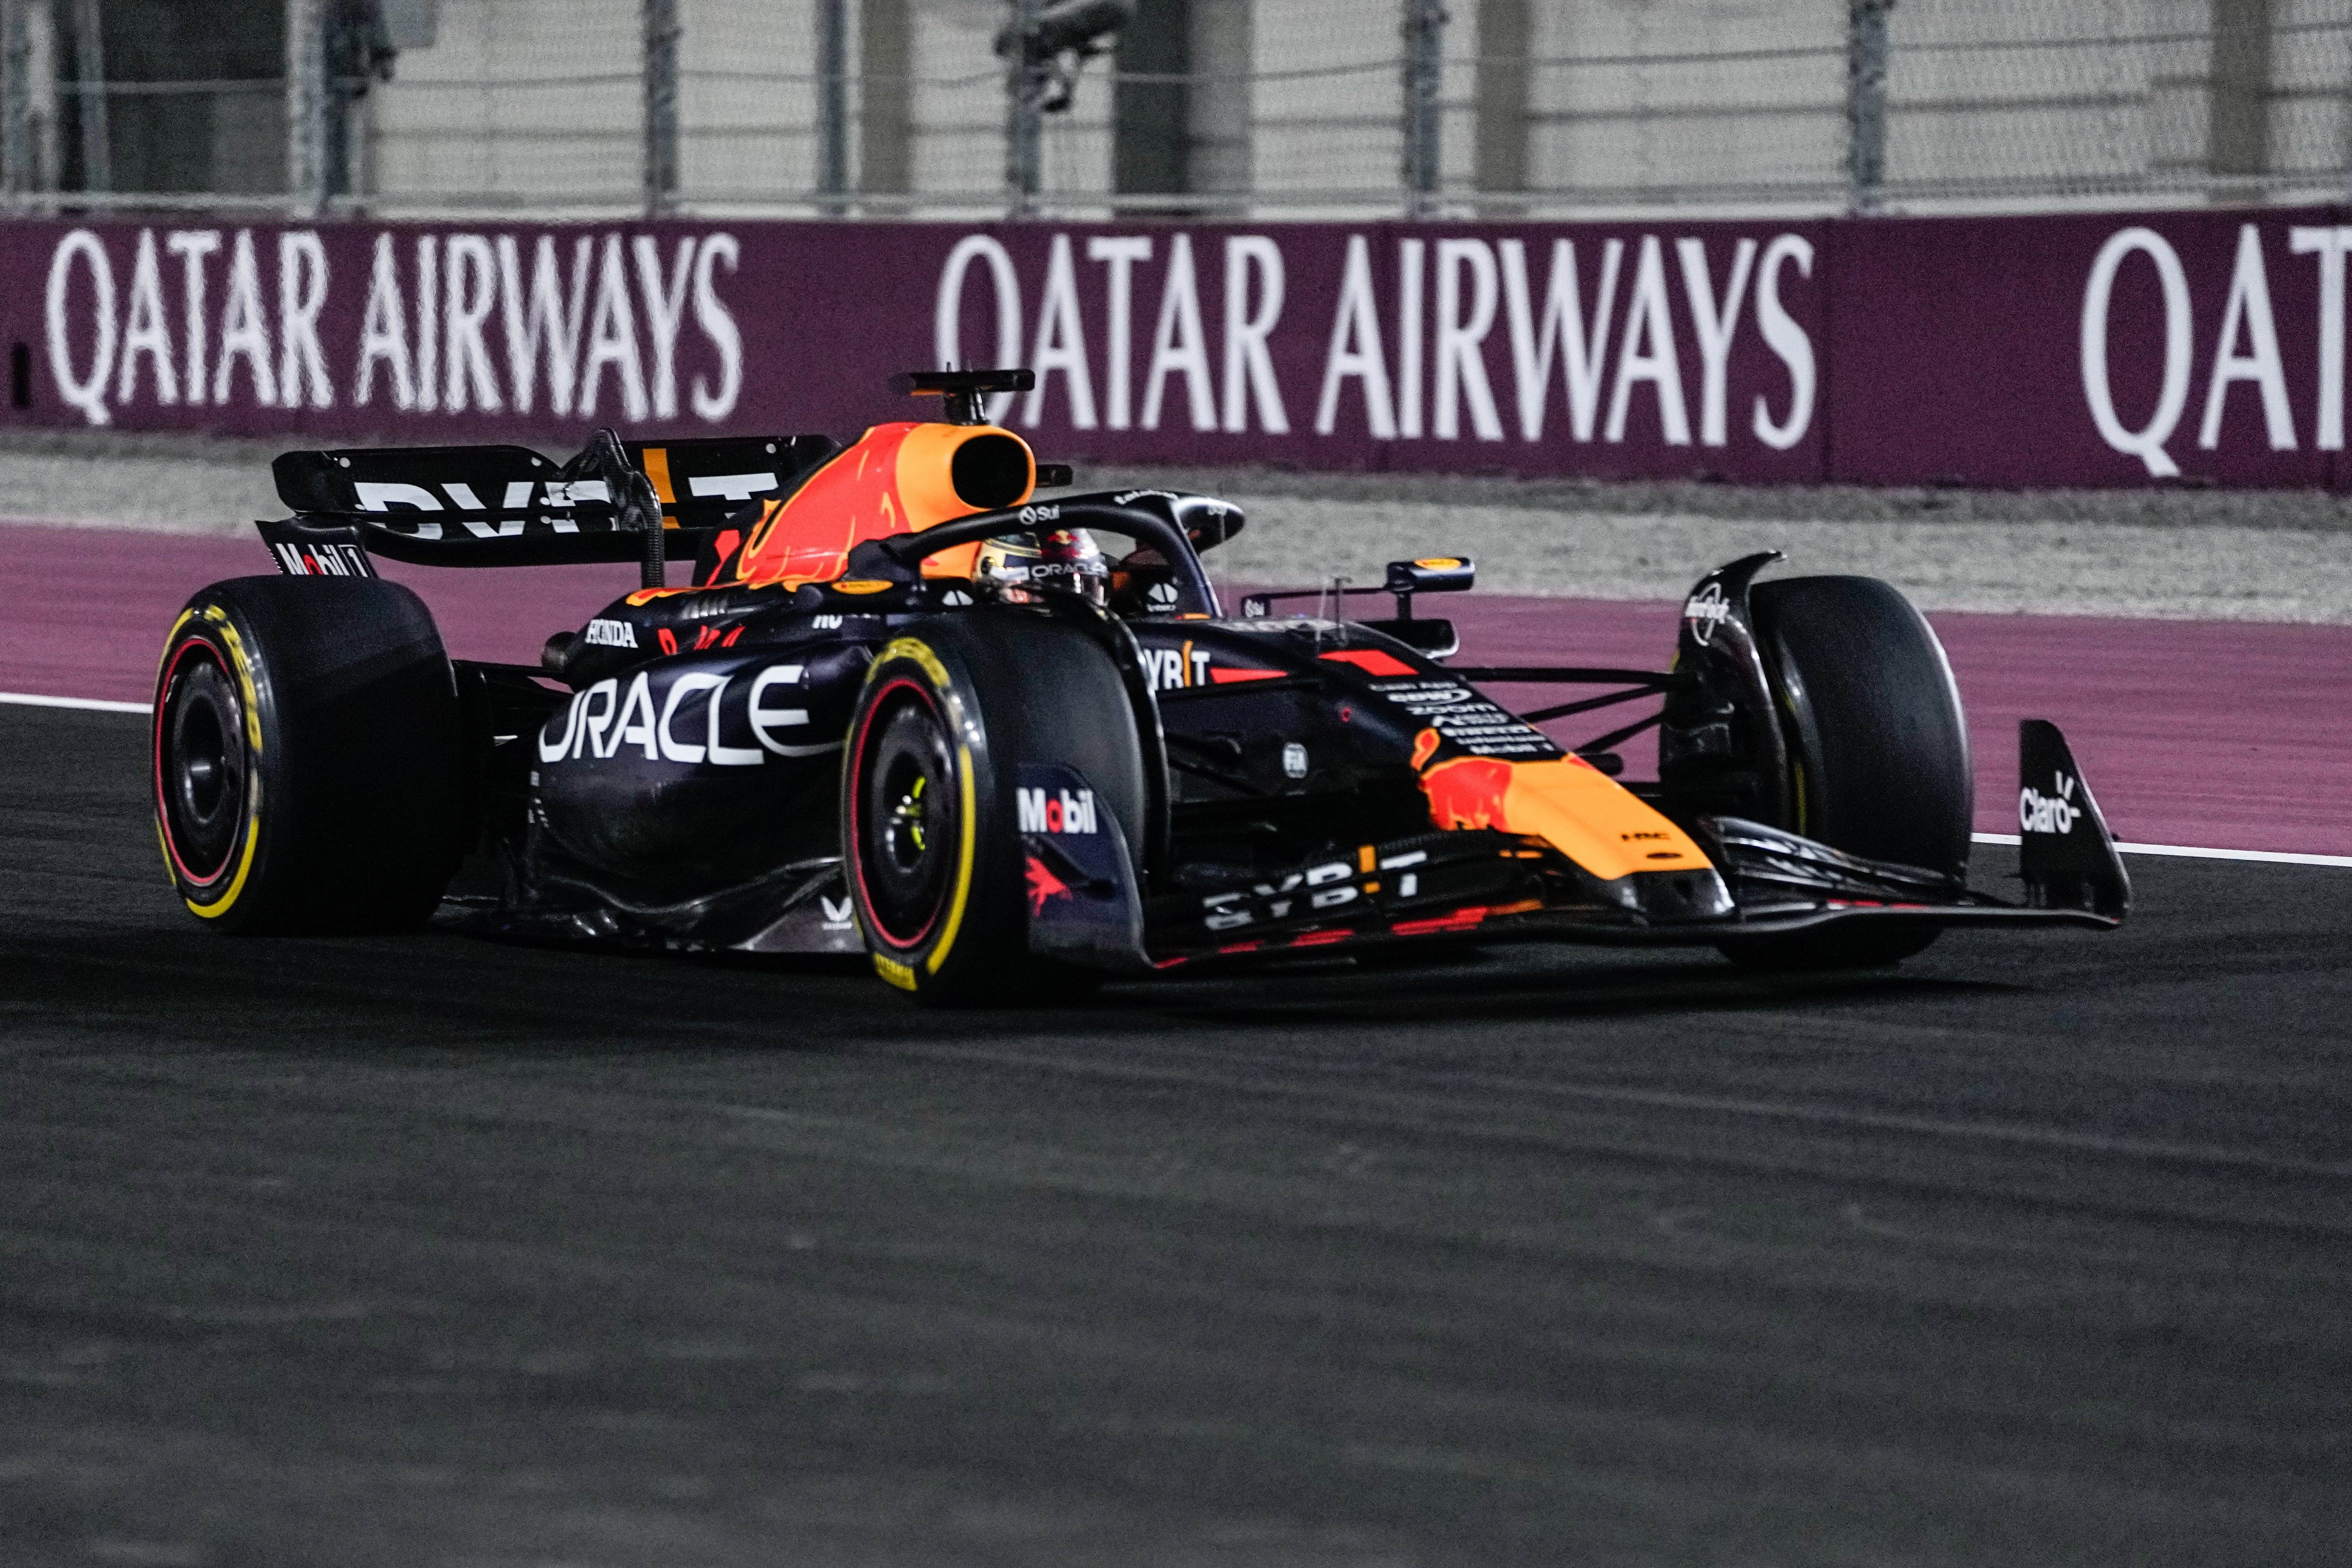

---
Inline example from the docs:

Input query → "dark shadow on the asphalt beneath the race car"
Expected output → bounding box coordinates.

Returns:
[0,926,2034,1053]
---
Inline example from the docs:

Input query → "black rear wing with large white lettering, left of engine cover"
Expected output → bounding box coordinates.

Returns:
[259,430,840,576]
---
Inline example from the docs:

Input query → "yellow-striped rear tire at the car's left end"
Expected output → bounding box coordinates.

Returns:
[153,576,466,936]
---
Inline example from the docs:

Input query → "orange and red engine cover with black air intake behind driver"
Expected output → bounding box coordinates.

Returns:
[736,421,1037,588]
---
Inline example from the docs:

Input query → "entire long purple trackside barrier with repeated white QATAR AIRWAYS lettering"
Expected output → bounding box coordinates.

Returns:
[0,209,2352,487]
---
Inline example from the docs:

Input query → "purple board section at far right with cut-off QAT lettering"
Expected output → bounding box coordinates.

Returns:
[1827,209,2352,487]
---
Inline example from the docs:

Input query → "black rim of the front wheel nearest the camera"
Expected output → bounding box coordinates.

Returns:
[854,682,962,947]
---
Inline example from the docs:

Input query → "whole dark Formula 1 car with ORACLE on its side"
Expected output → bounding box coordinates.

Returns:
[153,371,2128,1001]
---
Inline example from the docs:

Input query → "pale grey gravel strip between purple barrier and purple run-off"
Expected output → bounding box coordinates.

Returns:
[0,430,2352,623]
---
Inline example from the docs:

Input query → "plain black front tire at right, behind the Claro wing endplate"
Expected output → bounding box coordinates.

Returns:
[1724,576,1976,968]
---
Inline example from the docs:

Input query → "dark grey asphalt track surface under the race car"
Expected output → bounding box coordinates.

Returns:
[0,707,2352,1568]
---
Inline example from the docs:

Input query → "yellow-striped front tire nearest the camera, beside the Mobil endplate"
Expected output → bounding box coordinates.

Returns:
[842,609,1146,1004]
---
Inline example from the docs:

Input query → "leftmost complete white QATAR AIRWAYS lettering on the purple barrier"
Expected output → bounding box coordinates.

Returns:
[47,226,743,425]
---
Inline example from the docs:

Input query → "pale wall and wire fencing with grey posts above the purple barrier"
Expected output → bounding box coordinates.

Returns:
[0,0,2352,221]
